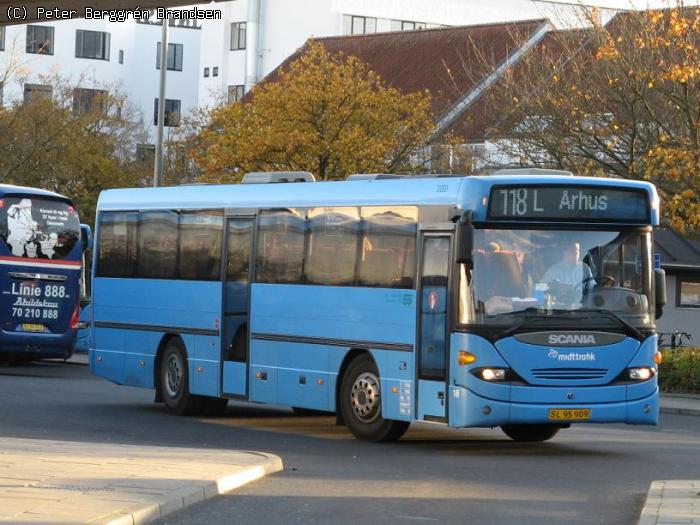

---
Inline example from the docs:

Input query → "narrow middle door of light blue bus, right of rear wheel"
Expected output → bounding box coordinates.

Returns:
[221,218,254,397]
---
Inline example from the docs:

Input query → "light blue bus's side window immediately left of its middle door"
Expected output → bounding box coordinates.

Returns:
[179,211,224,281]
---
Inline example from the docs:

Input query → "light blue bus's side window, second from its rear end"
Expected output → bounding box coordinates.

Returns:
[136,211,178,279]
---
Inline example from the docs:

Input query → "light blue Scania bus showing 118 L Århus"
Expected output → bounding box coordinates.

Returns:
[89,171,665,441]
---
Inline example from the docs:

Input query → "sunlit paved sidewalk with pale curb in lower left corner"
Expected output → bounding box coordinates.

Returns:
[0,438,282,525]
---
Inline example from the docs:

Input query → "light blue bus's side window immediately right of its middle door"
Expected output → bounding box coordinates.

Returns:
[255,210,306,284]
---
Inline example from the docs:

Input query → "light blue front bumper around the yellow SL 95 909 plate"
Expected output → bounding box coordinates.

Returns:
[449,386,659,428]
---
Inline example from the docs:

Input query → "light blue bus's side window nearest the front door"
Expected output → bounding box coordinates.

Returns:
[359,206,418,288]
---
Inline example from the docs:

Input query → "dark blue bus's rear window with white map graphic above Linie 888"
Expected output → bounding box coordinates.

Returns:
[0,196,80,260]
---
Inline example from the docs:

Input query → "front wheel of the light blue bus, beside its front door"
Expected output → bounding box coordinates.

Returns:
[340,354,410,443]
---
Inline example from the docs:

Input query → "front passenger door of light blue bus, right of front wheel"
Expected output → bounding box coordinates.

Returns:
[416,232,452,422]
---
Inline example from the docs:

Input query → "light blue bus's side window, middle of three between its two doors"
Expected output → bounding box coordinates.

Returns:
[304,208,360,286]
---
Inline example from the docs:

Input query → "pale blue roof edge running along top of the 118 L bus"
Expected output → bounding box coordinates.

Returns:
[98,175,658,224]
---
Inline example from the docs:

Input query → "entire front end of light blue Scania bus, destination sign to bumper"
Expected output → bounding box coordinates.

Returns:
[449,177,665,440]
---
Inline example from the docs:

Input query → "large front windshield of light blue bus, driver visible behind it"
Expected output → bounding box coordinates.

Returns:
[459,229,654,330]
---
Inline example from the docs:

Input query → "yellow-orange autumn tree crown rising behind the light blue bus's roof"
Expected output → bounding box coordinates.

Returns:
[189,42,433,182]
